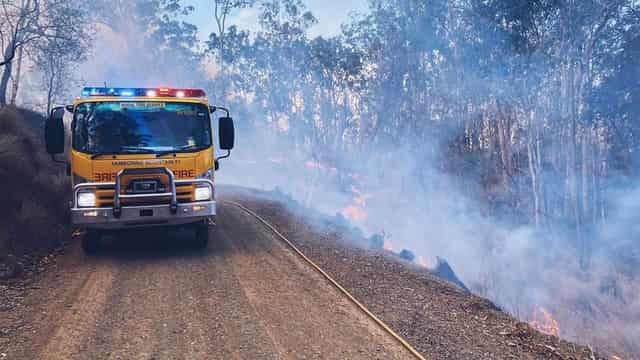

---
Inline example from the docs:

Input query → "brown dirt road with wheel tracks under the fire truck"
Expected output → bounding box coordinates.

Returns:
[0,204,411,359]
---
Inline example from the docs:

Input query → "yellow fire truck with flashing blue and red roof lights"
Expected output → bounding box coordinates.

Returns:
[45,87,235,254]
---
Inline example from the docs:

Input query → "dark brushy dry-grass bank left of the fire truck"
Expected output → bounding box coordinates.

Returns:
[0,107,70,260]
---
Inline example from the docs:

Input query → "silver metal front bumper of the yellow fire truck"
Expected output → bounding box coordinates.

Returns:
[71,201,216,229]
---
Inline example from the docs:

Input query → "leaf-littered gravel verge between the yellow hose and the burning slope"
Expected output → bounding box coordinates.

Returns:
[225,188,604,359]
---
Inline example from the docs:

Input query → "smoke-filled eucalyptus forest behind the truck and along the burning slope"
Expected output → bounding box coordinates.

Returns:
[0,0,640,358]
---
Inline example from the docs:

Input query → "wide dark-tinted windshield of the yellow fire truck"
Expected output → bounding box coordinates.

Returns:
[73,101,211,154]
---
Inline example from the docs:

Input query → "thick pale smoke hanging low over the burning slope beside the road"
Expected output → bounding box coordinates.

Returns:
[217,114,640,353]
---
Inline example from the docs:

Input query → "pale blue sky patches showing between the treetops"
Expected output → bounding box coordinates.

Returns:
[185,0,367,38]
